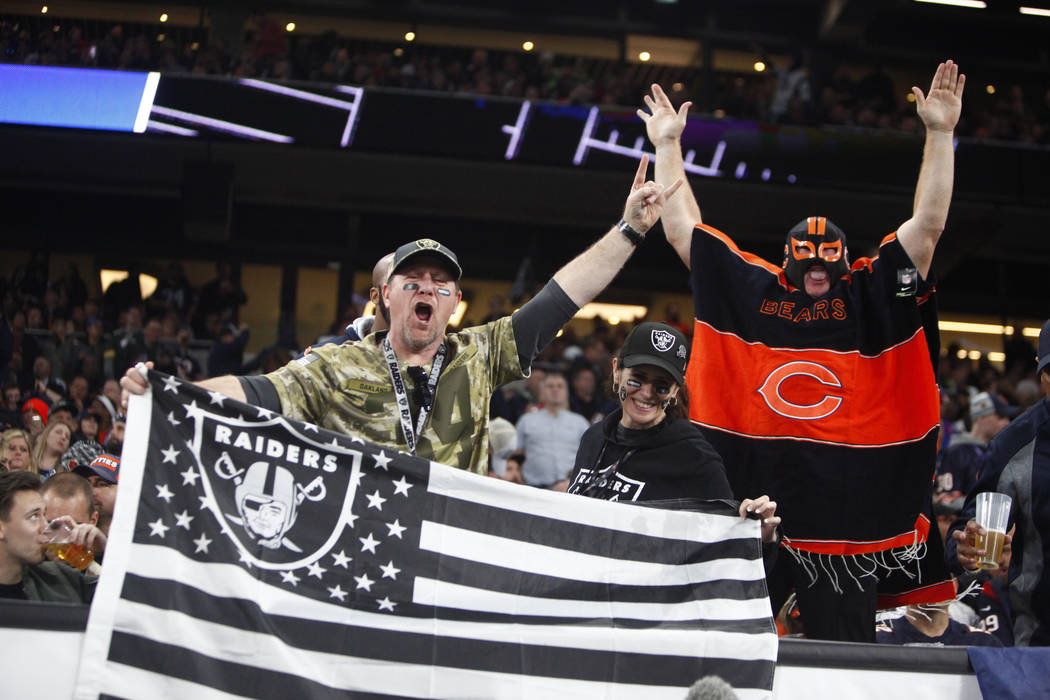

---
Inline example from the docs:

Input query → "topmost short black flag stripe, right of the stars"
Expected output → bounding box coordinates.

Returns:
[423,493,762,564]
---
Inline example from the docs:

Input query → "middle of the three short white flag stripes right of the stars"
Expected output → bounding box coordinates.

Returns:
[419,522,764,586]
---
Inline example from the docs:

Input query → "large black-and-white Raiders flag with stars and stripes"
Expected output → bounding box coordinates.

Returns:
[77,372,777,700]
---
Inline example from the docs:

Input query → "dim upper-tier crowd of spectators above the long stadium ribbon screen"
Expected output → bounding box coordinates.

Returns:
[0,9,1050,144]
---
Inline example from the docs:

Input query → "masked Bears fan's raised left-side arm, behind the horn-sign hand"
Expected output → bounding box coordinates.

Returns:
[638,83,700,268]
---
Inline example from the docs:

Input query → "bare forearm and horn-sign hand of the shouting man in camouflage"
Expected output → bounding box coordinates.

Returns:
[554,155,681,306]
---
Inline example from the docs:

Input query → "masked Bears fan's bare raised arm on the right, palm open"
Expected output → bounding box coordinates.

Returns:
[897,61,966,277]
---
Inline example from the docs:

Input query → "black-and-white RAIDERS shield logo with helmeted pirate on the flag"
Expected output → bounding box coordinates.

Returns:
[191,409,362,570]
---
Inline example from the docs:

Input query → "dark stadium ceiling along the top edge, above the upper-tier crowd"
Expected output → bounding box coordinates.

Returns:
[51,0,1050,72]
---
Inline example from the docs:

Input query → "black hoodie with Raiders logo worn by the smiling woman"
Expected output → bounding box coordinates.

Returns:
[569,408,735,512]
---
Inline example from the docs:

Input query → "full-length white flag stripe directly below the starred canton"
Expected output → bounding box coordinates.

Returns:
[121,544,777,661]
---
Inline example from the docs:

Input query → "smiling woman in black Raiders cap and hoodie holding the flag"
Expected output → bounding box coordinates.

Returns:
[568,322,780,542]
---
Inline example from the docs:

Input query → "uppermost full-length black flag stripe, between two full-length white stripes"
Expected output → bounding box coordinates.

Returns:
[119,580,774,697]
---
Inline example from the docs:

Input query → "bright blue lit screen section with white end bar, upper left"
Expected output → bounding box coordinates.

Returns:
[0,64,161,132]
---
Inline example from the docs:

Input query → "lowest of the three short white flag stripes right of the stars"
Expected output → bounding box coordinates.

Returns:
[412,576,770,622]
